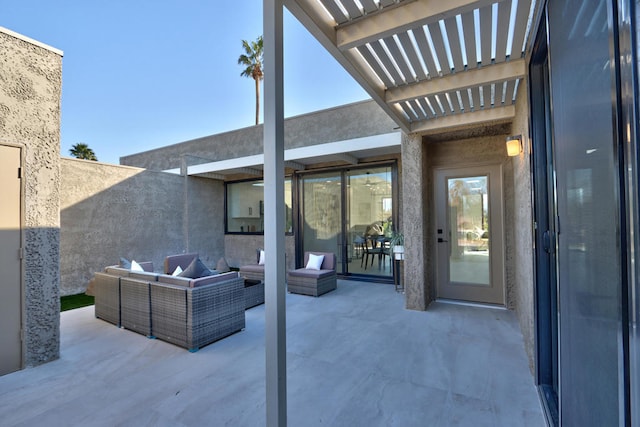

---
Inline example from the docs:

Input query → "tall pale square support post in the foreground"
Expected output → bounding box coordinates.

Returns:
[263,0,287,427]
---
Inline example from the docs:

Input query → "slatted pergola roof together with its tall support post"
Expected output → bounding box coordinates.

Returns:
[263,0,537,426]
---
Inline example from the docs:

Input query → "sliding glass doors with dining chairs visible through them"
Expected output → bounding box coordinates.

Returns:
[300,165,394,278]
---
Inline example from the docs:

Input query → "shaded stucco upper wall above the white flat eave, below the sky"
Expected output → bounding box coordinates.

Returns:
[120,101,397,170]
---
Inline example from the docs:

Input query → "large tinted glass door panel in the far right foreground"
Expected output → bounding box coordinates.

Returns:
[548,1,624,427]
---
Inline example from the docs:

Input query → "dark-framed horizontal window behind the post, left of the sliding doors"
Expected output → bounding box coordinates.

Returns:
[226,179,293,234]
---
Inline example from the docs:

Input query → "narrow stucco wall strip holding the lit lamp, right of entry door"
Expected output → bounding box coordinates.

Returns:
[510,85,535,371]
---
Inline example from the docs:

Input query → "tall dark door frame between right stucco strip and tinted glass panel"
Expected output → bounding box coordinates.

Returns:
[529,11,562,426]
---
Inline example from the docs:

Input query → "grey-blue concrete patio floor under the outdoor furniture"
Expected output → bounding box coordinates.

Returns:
[0,281,546,427]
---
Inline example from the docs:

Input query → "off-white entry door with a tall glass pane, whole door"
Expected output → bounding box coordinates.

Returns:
[435,165,504,305]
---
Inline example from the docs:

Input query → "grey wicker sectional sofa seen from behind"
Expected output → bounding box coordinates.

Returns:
[93,266,245,352]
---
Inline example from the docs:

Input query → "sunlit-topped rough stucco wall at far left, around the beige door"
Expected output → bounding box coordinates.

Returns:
[0,28,62,367]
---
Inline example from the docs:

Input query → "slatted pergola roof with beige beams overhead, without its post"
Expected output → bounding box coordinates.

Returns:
[284,0,535,134]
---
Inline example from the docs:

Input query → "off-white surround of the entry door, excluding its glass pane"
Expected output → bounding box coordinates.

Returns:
[433,163,506,306]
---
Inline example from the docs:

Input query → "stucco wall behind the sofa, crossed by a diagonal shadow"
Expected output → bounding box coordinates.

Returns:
[60,158,224,295]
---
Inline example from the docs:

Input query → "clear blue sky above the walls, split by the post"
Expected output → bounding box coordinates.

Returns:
[0,0,368,163]
